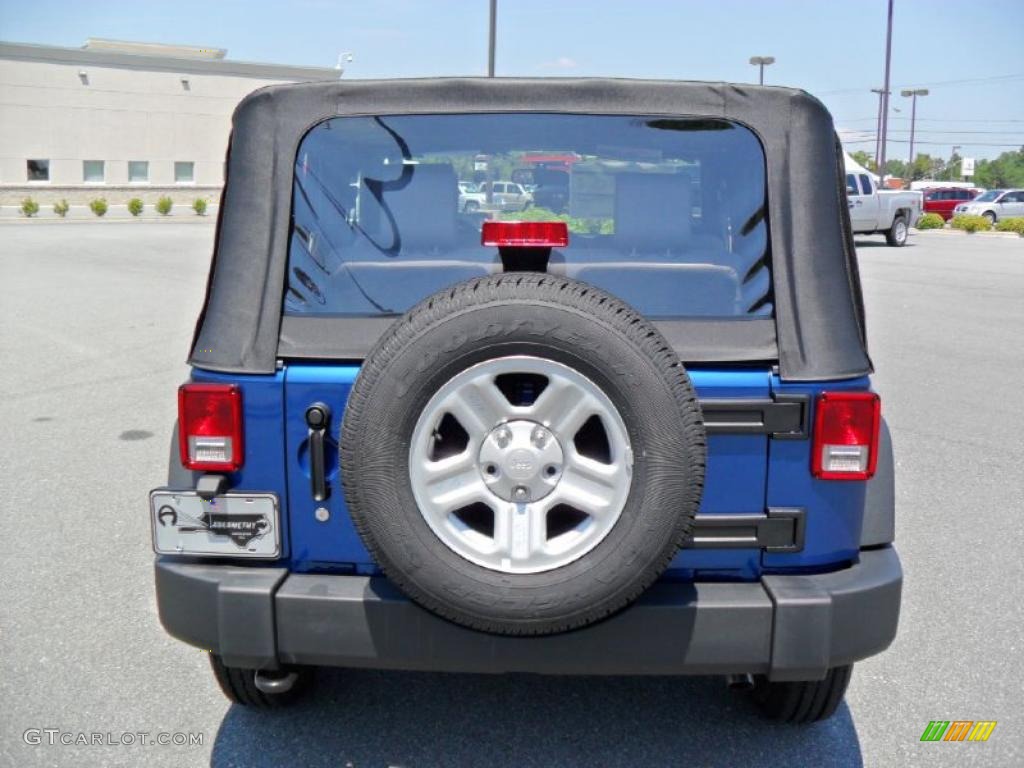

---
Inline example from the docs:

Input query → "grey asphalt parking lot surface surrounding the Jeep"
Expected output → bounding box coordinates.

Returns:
[0,221,1024,768]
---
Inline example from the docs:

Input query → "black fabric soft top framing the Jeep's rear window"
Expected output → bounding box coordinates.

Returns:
[189,78,871,381]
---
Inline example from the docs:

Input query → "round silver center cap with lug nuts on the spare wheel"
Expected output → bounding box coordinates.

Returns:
[478,419,563,503]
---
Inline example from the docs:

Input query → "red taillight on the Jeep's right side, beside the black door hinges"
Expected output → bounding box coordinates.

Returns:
[811,392,882,480]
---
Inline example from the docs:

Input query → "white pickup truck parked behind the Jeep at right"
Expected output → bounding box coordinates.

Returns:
[846,156,924,248]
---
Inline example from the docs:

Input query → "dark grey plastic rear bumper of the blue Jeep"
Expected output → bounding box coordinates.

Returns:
[156,547,902,680]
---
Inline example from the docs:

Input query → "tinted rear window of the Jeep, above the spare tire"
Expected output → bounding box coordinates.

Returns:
[285,113,773,319]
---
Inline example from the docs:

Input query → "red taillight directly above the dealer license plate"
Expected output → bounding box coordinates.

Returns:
[178,384,244,472]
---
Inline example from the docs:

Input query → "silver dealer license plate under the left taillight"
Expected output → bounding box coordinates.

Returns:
[150,488,281,559]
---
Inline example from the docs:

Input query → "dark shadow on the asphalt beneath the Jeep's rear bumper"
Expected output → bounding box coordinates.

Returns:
[210,671,863,768]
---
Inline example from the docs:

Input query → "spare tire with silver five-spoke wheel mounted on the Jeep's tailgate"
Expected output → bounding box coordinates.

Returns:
[340,273,706,635]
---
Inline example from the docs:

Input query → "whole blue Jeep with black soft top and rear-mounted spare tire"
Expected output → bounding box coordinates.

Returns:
[151,79,902,722]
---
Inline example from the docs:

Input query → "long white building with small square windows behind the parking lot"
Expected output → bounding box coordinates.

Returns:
[0,39,341,205]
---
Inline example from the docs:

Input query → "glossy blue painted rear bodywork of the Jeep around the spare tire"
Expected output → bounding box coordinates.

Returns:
[184,364,870,581]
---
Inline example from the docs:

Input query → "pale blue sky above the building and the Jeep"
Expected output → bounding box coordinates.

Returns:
[0,0,1024,159]
